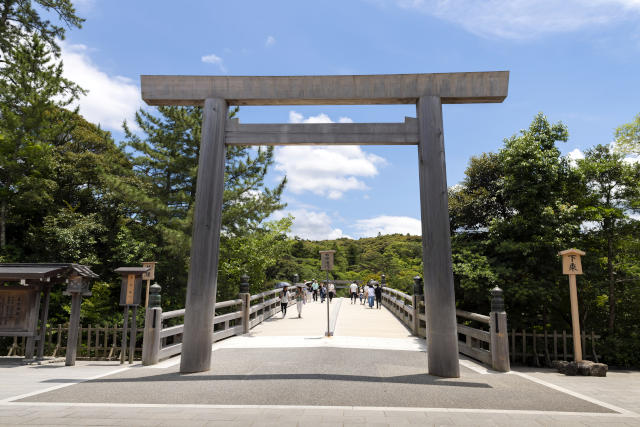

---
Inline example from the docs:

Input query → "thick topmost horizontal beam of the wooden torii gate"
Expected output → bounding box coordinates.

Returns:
[140,71,509,105]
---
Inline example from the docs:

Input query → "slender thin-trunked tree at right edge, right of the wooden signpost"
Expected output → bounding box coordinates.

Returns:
[578,145,640,333]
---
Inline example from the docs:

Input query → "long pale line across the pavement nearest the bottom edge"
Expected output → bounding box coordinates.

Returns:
[0,402,639,418]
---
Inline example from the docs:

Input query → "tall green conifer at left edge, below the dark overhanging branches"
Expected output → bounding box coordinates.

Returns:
[0,34,82,250]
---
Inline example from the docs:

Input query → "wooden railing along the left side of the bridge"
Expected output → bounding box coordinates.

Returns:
[142,284,294,365]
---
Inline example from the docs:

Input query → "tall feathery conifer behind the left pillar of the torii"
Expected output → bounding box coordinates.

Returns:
[124,107,287,305]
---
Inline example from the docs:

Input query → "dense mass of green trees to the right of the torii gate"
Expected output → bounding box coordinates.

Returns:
[449,114,640,366]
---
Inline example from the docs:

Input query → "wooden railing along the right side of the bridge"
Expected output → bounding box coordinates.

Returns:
[382,283,510,372]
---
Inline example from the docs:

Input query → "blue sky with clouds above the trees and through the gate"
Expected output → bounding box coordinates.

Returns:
[63,0,640,239]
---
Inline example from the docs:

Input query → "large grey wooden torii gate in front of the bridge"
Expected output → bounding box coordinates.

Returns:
[141,71,509,378]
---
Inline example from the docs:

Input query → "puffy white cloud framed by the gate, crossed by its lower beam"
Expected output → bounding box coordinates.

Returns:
[275,111,386,199]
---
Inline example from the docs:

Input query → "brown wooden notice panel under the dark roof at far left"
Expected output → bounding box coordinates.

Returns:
[0,287,40,336]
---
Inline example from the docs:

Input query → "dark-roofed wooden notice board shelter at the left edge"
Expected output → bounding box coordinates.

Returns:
[0,263,98,359]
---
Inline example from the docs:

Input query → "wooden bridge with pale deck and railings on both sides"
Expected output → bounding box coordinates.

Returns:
[142,286,509,372]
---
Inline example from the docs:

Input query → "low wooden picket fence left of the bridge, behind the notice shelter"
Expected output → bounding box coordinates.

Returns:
[7,324,142,360]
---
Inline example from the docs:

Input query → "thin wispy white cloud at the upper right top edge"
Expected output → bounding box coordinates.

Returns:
[394,0,640,40]
